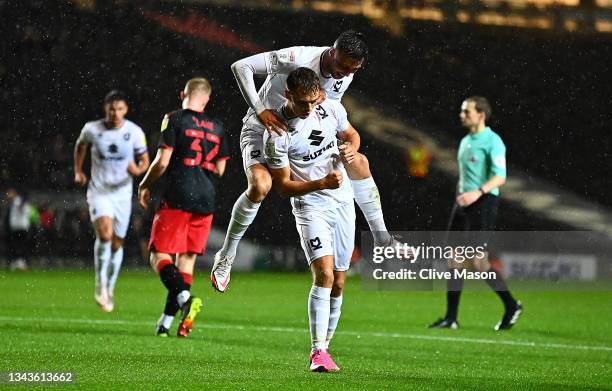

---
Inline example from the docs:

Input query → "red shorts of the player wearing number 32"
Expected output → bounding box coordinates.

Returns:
[149,206,213,254]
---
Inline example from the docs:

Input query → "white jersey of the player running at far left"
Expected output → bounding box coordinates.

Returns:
[78,119,147,191]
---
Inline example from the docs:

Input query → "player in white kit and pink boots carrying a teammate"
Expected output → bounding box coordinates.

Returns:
[264,68,360,372]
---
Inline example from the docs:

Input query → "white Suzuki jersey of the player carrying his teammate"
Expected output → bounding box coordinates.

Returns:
[264,100,353,210]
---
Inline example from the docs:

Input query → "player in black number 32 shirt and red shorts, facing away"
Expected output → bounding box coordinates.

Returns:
[138,78,229,337]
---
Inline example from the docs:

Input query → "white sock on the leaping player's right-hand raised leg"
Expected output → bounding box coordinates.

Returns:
[351,177,392,246]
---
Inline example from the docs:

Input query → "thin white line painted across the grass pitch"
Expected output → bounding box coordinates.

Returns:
[0,316,612,352]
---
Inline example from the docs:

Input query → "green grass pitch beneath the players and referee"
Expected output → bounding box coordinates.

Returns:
[0,270,612,391]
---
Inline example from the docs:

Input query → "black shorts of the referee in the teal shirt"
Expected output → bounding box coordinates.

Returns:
[448,194,499,245]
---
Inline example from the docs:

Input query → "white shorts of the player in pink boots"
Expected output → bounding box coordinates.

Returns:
[293,202,355,271]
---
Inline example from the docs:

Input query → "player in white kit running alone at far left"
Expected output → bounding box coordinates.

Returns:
[74,90,149,312]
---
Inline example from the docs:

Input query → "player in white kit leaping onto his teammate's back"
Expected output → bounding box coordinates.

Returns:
[211,30,394,292]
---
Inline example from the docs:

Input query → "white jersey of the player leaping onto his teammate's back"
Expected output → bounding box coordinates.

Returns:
[243,46,353,125]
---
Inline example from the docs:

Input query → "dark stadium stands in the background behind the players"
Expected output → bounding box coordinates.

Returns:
[0,0,612,263]
